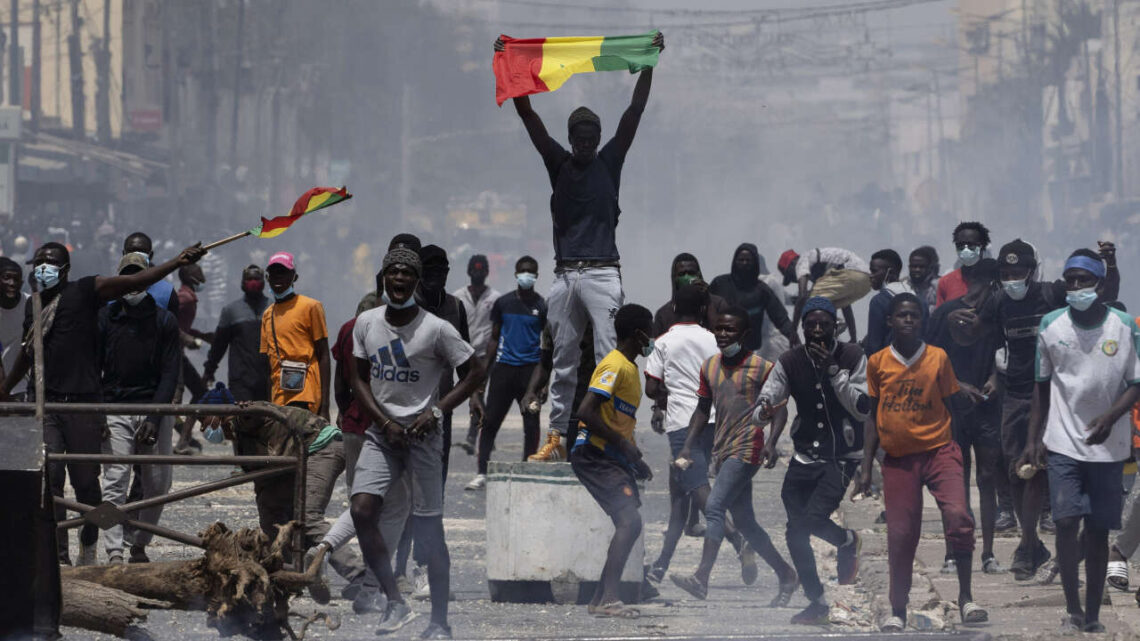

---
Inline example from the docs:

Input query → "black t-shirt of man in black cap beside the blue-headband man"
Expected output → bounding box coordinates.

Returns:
[982,281,1066,398]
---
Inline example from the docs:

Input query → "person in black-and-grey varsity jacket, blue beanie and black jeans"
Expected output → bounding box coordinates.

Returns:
[755,296,873,625]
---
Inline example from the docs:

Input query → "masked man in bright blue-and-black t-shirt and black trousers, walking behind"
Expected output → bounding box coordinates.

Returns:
[466,255,546,490]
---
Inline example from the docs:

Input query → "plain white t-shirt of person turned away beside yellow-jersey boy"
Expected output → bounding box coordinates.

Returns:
[645,323,719,432]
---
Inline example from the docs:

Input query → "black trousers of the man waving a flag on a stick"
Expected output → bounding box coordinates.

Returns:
[43,414,106,557]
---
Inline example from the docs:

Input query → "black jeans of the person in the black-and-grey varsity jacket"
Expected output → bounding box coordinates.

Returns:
[780,460,858,601]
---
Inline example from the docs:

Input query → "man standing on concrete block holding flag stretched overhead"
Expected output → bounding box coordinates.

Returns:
[495,33,665,461]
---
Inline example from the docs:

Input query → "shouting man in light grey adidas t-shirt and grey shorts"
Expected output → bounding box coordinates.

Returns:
[350,248,483,639]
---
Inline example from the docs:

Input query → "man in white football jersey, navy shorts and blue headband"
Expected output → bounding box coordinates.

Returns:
[1018,250,1140,632]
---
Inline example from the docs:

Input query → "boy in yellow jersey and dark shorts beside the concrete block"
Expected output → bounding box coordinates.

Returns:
[570,305,653,618]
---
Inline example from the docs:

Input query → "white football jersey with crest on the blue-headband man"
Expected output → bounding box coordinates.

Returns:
[1036,307,1140,462]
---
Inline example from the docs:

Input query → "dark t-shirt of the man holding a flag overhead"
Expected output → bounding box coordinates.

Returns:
[542,138,626,260]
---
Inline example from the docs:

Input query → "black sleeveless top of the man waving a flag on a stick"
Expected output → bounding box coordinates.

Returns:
[24,276,103,398]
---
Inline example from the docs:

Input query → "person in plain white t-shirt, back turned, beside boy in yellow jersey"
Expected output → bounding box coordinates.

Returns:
[645,284,757,585]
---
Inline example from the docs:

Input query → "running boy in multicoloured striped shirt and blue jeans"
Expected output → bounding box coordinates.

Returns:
[669,307,799,608]
